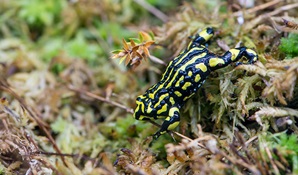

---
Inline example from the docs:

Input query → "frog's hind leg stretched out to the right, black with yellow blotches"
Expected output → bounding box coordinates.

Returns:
[208,47,258,70]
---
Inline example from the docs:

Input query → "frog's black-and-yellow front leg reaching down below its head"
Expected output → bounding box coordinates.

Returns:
[153,107,180,139]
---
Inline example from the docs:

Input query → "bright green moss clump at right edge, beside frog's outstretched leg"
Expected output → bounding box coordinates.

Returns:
[279,33,298,58]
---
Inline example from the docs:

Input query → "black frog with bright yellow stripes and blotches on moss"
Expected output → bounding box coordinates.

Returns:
[133,27,258,139]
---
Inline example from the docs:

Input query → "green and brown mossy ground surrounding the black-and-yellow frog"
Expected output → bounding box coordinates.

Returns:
[0,0,298,174]
